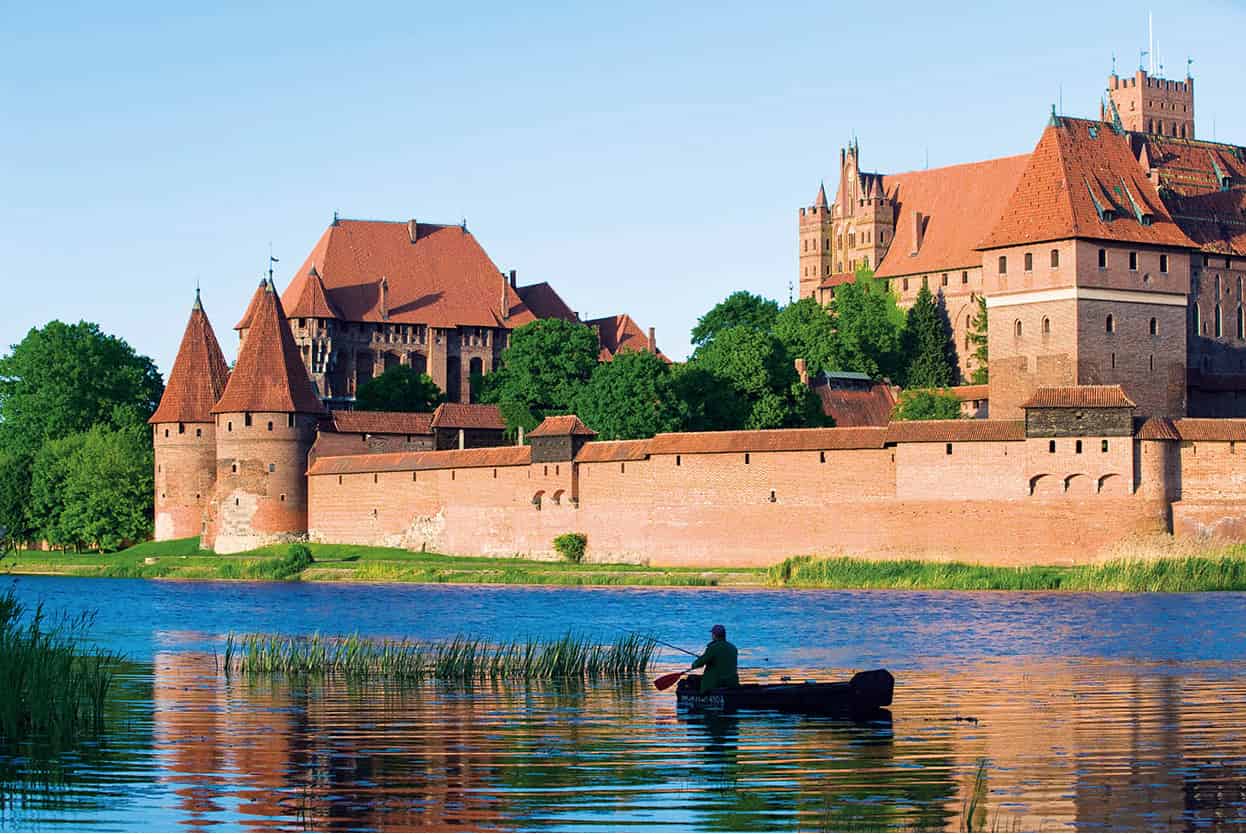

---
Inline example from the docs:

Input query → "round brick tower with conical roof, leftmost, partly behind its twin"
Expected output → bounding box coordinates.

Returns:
[148,290,229,541]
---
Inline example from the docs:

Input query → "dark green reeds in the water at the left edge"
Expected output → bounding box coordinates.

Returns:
[0,587,121,749]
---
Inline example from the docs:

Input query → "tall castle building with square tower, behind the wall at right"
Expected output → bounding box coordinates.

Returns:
[799,70,1246,419]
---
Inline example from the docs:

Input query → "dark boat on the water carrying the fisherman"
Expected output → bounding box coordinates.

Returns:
[675,669,896,718]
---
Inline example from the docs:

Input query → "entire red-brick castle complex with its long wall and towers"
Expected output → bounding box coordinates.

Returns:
[151,61,1246,567]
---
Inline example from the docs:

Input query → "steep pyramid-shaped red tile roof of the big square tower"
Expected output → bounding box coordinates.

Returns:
[981,117,1195,249]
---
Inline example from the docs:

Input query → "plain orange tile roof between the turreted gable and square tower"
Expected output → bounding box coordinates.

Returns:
[875,155,1029,278]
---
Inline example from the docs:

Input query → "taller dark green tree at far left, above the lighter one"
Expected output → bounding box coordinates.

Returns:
[0,322,164,458]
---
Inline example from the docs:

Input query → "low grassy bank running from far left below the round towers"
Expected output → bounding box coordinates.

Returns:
[0,539,765,587]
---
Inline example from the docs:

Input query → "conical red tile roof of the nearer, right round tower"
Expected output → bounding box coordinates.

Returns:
[212,281,324,414]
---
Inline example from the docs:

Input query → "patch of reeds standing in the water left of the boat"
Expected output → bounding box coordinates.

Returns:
[224,632,657,682]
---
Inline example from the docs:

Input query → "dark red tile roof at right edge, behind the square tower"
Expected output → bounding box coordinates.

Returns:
[1130,133,1246,254]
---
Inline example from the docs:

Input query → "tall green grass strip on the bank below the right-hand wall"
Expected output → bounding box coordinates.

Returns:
[766,552,1246,593]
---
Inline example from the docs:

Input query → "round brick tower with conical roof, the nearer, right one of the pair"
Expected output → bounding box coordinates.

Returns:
[203,282,324,554]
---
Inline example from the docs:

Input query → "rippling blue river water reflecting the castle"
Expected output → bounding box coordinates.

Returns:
[0,577,1246,830]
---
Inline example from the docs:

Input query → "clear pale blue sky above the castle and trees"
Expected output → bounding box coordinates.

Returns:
[0,0,1246,373]
